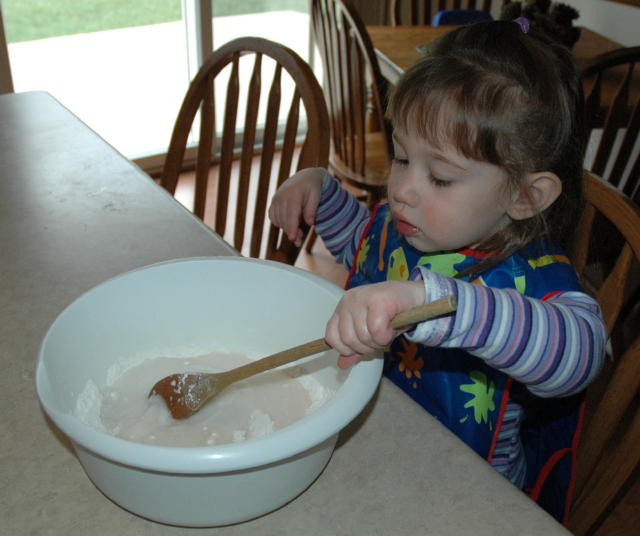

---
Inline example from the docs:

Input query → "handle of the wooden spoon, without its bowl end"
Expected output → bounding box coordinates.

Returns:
[219,296,456,383]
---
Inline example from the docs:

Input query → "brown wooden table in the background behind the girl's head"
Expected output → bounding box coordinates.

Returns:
[367,25,622,84]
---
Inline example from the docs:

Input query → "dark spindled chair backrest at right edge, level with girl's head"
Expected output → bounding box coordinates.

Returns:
[582,47,640,204]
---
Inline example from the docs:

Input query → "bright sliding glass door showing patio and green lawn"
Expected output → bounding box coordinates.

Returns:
[0,0,309,165]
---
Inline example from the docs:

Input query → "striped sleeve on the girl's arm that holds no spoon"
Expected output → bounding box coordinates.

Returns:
[315,172,370,270]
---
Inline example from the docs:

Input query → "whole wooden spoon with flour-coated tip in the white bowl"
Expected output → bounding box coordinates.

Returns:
[149,296,456,419]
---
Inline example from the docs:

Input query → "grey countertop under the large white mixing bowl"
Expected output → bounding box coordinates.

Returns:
[0,92,569,536]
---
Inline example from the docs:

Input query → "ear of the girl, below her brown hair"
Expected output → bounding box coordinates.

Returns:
[507,171,562,220]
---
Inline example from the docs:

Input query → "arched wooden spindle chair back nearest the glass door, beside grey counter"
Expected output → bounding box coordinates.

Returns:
[161,37,330,264]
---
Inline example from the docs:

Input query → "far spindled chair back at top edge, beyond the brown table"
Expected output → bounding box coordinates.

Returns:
[387,0,508,26]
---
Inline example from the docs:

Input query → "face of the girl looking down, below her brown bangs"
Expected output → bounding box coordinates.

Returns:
[388,124,513,252]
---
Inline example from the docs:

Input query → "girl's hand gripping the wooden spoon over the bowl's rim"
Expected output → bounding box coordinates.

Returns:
[325,281,425,368]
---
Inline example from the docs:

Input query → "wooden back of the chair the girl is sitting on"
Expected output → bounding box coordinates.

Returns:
[569,171,640,534]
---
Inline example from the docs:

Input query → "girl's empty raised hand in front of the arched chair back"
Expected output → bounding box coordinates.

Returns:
[269,168,326,247]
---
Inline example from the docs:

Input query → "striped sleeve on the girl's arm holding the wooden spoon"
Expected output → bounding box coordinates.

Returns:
[408,268,607,398]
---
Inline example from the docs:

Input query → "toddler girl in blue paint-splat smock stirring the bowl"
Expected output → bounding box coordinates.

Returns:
[270,21,607,520]
